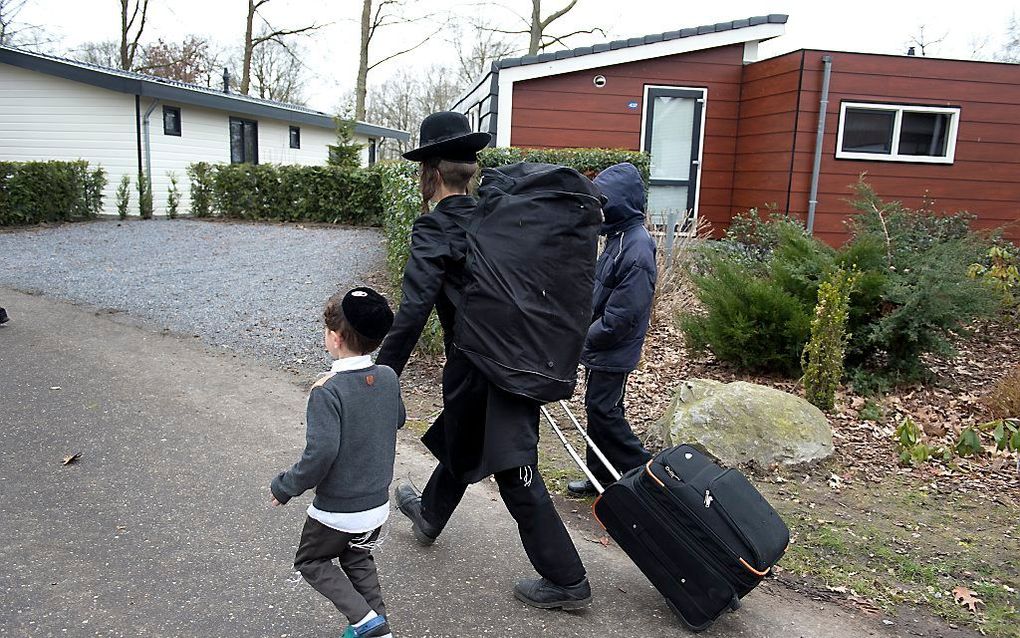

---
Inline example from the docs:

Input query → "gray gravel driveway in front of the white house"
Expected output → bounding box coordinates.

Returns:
[0,219,386,372]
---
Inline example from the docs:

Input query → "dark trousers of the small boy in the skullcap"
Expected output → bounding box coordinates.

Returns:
[294,517,386,625]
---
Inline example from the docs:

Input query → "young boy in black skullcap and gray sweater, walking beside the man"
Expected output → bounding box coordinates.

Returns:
[270,288,405,638]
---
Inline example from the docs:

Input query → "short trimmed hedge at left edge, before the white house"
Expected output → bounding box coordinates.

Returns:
[0,160,106,226]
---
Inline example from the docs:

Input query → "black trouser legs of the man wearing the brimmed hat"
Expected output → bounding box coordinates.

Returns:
[421,463,584,586]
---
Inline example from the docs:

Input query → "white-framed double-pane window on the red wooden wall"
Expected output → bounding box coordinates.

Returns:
[835,102,960,164]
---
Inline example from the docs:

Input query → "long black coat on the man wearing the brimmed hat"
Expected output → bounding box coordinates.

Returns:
[376,195,539,483]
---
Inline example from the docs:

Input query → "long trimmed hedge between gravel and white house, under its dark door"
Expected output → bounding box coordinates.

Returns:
[188,162,383,226]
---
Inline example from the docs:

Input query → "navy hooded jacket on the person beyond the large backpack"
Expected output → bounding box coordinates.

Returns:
[580,163,656,373]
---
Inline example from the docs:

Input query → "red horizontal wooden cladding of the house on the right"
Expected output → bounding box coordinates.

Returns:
[501,45,1020,244]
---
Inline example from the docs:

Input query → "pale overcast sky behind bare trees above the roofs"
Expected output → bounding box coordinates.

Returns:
[20,0,1020,111]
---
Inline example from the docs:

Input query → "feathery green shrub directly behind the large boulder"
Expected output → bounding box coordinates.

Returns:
[680,254,811,375]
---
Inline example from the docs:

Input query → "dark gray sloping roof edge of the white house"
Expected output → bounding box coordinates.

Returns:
[0,47,411,141]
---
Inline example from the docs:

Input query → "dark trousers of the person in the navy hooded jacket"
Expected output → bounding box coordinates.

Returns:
[584,369,652,485]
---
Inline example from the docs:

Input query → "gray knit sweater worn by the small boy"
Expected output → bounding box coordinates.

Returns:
[270,365,406,512]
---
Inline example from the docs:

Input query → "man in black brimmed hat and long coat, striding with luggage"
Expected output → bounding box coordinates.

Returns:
[377,111,592,609]
